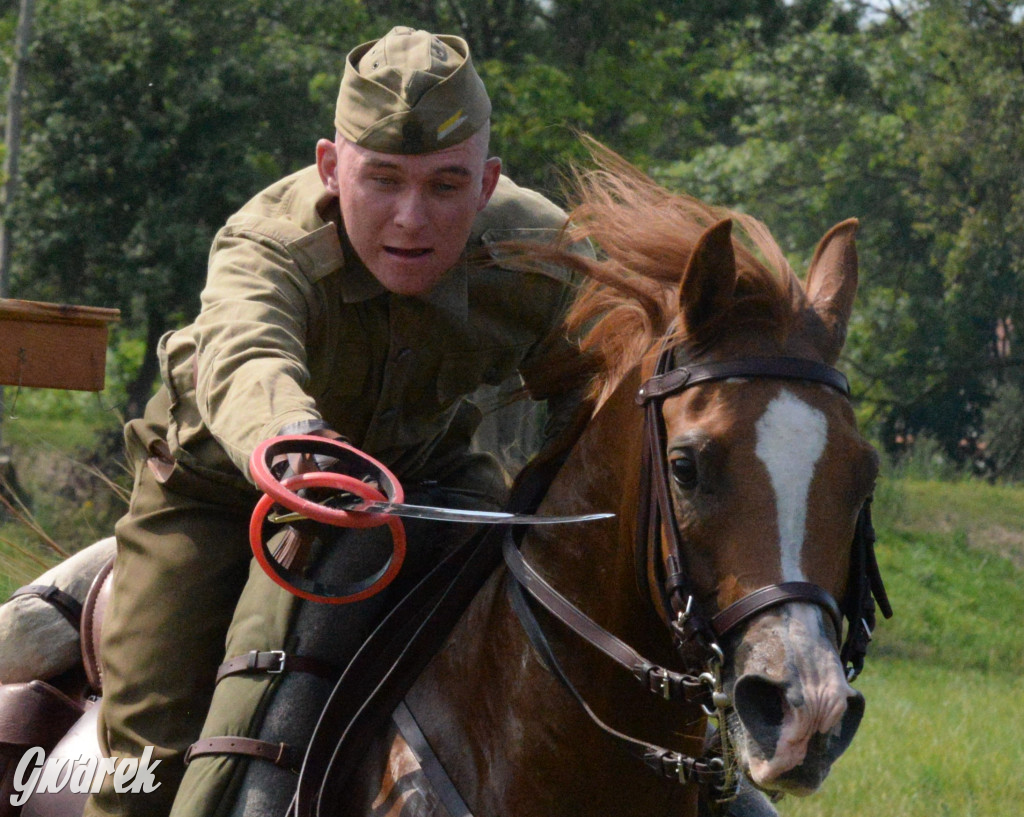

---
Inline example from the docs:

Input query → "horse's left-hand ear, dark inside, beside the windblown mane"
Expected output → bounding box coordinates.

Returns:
[679,218,736,336]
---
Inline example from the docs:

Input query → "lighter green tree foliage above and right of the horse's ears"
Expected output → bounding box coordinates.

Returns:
[664,0,1024,464]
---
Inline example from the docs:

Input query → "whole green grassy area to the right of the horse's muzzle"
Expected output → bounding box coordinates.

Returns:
[778,479,1024,817]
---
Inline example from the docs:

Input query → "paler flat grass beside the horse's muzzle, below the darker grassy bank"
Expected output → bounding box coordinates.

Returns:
[777,658,1024,817]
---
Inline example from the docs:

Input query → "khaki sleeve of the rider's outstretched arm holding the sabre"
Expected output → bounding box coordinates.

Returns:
[195,228,321,476]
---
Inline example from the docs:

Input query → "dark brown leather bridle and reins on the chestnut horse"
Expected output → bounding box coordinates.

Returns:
[503,346,892,805]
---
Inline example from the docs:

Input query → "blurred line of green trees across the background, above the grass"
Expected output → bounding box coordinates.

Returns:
[0,0,1024,505]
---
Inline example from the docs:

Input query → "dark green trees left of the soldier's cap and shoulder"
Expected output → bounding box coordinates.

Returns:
[3,0,366,415]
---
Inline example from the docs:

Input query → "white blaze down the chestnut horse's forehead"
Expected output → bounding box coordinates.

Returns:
[756,389,828,582]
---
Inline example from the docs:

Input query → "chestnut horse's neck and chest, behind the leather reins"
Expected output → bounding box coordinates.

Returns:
[410,362,703,817]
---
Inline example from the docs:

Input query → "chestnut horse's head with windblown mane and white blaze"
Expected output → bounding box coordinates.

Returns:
[528,145,890,806]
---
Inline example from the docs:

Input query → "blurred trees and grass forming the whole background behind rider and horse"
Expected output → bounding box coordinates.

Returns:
[0,7,1024,817]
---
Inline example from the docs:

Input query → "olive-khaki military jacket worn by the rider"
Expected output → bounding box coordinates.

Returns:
[152,163,570,489]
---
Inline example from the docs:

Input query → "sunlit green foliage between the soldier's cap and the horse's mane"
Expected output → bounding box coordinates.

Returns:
[352,0,815,185]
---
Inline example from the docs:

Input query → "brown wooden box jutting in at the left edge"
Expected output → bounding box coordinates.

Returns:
[0,299,121,391]
